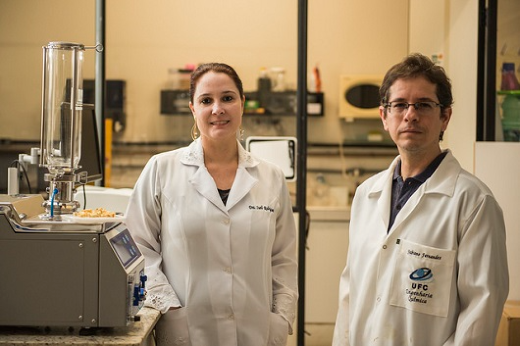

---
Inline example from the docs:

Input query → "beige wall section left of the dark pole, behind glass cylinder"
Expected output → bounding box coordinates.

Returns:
[0,0,95,140]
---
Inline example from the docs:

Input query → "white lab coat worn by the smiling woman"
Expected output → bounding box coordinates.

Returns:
[126,139,297,346]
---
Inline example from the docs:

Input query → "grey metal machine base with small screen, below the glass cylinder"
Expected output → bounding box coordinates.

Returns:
[0,195,146,327]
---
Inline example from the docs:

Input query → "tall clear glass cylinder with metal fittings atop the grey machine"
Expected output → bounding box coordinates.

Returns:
[40,42,85,217]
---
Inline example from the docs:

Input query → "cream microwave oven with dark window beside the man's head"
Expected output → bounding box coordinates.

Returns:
[339,75,383,119]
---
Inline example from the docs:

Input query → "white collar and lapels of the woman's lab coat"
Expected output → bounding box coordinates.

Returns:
[181,138,259,214]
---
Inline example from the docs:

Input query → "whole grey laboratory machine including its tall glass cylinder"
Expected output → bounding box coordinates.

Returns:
[0,42,146,328]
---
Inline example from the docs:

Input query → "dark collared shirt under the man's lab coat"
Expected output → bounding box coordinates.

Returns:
[388,151,448,231]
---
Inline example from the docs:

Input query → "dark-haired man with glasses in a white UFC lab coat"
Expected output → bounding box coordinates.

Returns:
[333,54,509,346]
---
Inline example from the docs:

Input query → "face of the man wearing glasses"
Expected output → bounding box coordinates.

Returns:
[379,77,451,155]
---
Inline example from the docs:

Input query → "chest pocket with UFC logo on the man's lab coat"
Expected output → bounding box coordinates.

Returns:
[389,239,455,317]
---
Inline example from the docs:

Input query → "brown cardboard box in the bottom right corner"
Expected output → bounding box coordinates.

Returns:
[495,300,520,346]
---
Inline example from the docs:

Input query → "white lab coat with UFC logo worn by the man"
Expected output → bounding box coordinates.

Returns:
[333,152,509,346]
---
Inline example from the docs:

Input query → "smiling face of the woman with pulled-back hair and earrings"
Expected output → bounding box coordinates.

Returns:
[190,71,245,141]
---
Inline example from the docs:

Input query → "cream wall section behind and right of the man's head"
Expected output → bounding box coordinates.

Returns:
[410,0,478,172]
